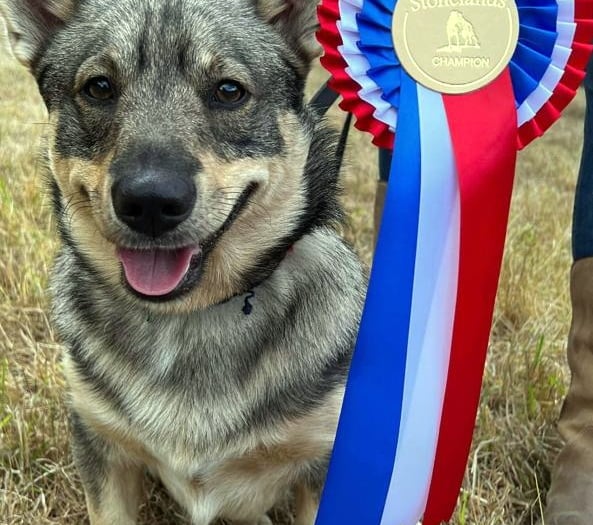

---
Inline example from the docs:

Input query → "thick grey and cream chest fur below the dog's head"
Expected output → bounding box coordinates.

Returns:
[52,229,364,516]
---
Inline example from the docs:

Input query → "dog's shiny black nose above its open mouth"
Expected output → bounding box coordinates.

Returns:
[111,171,196,237]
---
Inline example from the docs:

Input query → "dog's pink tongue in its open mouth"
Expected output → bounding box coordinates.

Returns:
[117,248,195,296]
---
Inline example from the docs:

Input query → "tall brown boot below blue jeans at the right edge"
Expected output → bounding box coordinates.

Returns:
[545,258,593,525]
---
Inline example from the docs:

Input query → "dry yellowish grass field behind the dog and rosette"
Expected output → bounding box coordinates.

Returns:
[0,31,584,525]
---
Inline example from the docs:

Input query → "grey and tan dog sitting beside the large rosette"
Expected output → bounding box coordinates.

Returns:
[0,0,366,525]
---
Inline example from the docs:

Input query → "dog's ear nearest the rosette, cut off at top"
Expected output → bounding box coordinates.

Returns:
[253,0,321,73]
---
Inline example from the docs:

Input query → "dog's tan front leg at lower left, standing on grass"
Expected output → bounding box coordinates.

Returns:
[70,411,142,525]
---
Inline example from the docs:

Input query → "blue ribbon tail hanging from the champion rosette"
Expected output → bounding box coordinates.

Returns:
[316,74,420,525]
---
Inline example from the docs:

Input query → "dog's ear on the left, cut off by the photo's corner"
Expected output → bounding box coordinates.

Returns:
[0,0,78,69]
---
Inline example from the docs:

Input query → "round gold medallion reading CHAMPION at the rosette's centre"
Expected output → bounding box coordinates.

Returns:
[392,0,519,93]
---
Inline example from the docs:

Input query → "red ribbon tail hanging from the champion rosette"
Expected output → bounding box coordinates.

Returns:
[423,68,517,525]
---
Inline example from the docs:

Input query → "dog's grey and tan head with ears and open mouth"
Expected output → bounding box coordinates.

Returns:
[0,0,318,309]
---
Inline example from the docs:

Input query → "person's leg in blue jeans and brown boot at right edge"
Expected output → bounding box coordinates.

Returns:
[545,58,593,525]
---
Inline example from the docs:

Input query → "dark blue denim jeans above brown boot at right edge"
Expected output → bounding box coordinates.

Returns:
[572,57,593,261]
